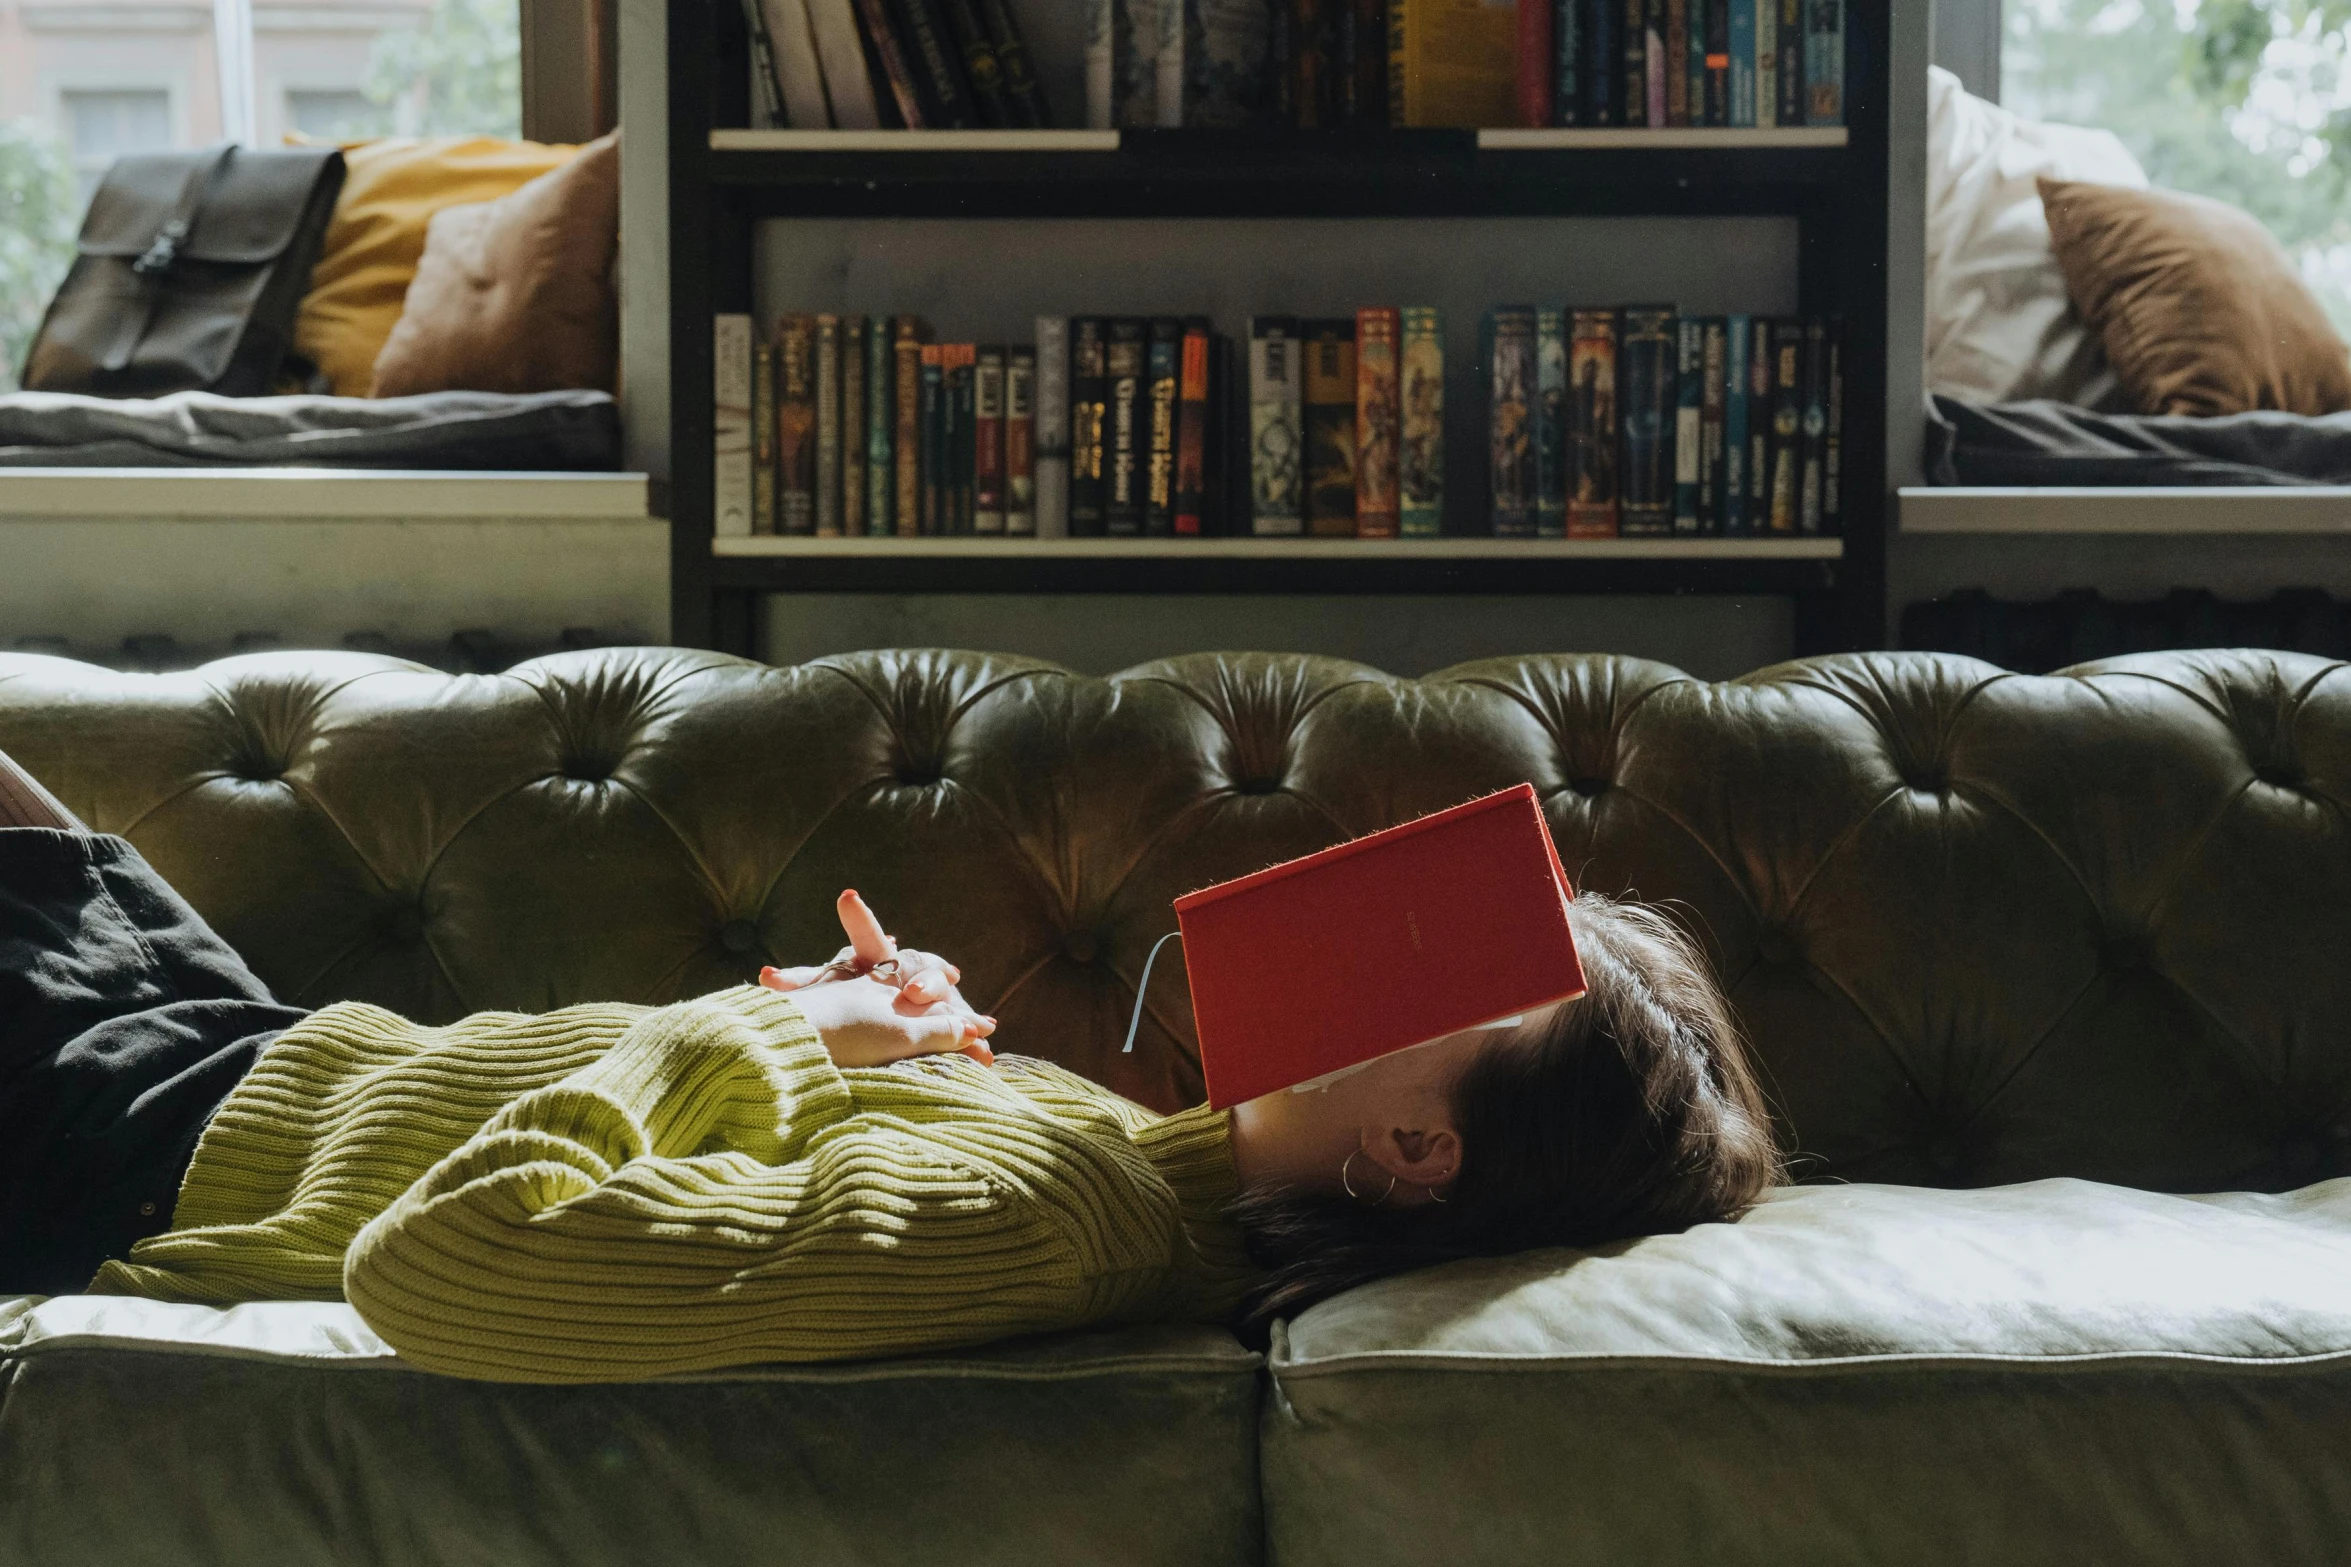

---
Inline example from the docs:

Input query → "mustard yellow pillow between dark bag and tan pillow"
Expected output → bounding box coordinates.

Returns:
[294,136,578,397]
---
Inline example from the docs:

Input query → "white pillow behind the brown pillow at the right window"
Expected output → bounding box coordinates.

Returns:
[1925,64,2146,406]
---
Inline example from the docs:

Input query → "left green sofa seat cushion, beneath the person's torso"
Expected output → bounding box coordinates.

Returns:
[0,1297,1260,1567]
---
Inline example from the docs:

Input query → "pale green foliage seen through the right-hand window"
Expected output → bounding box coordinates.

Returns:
[2001,0,2351,334]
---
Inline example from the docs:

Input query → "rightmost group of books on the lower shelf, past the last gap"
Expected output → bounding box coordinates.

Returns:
[1481,305,1846,538]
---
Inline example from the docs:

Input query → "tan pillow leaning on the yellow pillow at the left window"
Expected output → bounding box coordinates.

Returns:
[369,132,621,397]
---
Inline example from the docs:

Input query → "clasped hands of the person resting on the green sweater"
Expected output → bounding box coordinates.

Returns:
[759,890,997,1067]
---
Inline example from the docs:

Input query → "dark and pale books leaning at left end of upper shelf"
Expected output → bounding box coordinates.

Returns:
[743,0,1053,132]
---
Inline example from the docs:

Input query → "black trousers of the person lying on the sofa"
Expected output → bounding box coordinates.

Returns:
[0,827,308,1294]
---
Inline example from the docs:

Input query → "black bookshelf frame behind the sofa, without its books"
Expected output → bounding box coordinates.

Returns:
[665,0,1897,653]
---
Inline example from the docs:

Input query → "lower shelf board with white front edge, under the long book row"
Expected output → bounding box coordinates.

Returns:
[710,538,1843,597]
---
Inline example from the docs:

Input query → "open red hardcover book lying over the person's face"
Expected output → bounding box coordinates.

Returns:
[1176,785,1585,1109]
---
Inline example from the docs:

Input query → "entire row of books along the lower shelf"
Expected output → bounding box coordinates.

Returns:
[715,305,1843,538]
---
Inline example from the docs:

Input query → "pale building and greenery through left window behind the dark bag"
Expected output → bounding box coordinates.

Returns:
[0,0,522,390]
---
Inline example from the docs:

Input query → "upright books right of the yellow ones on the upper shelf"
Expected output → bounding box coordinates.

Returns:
[1516,0,1846,127]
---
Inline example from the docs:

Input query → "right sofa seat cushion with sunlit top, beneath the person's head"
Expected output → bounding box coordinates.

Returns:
[1265,1179,2351,1567]
